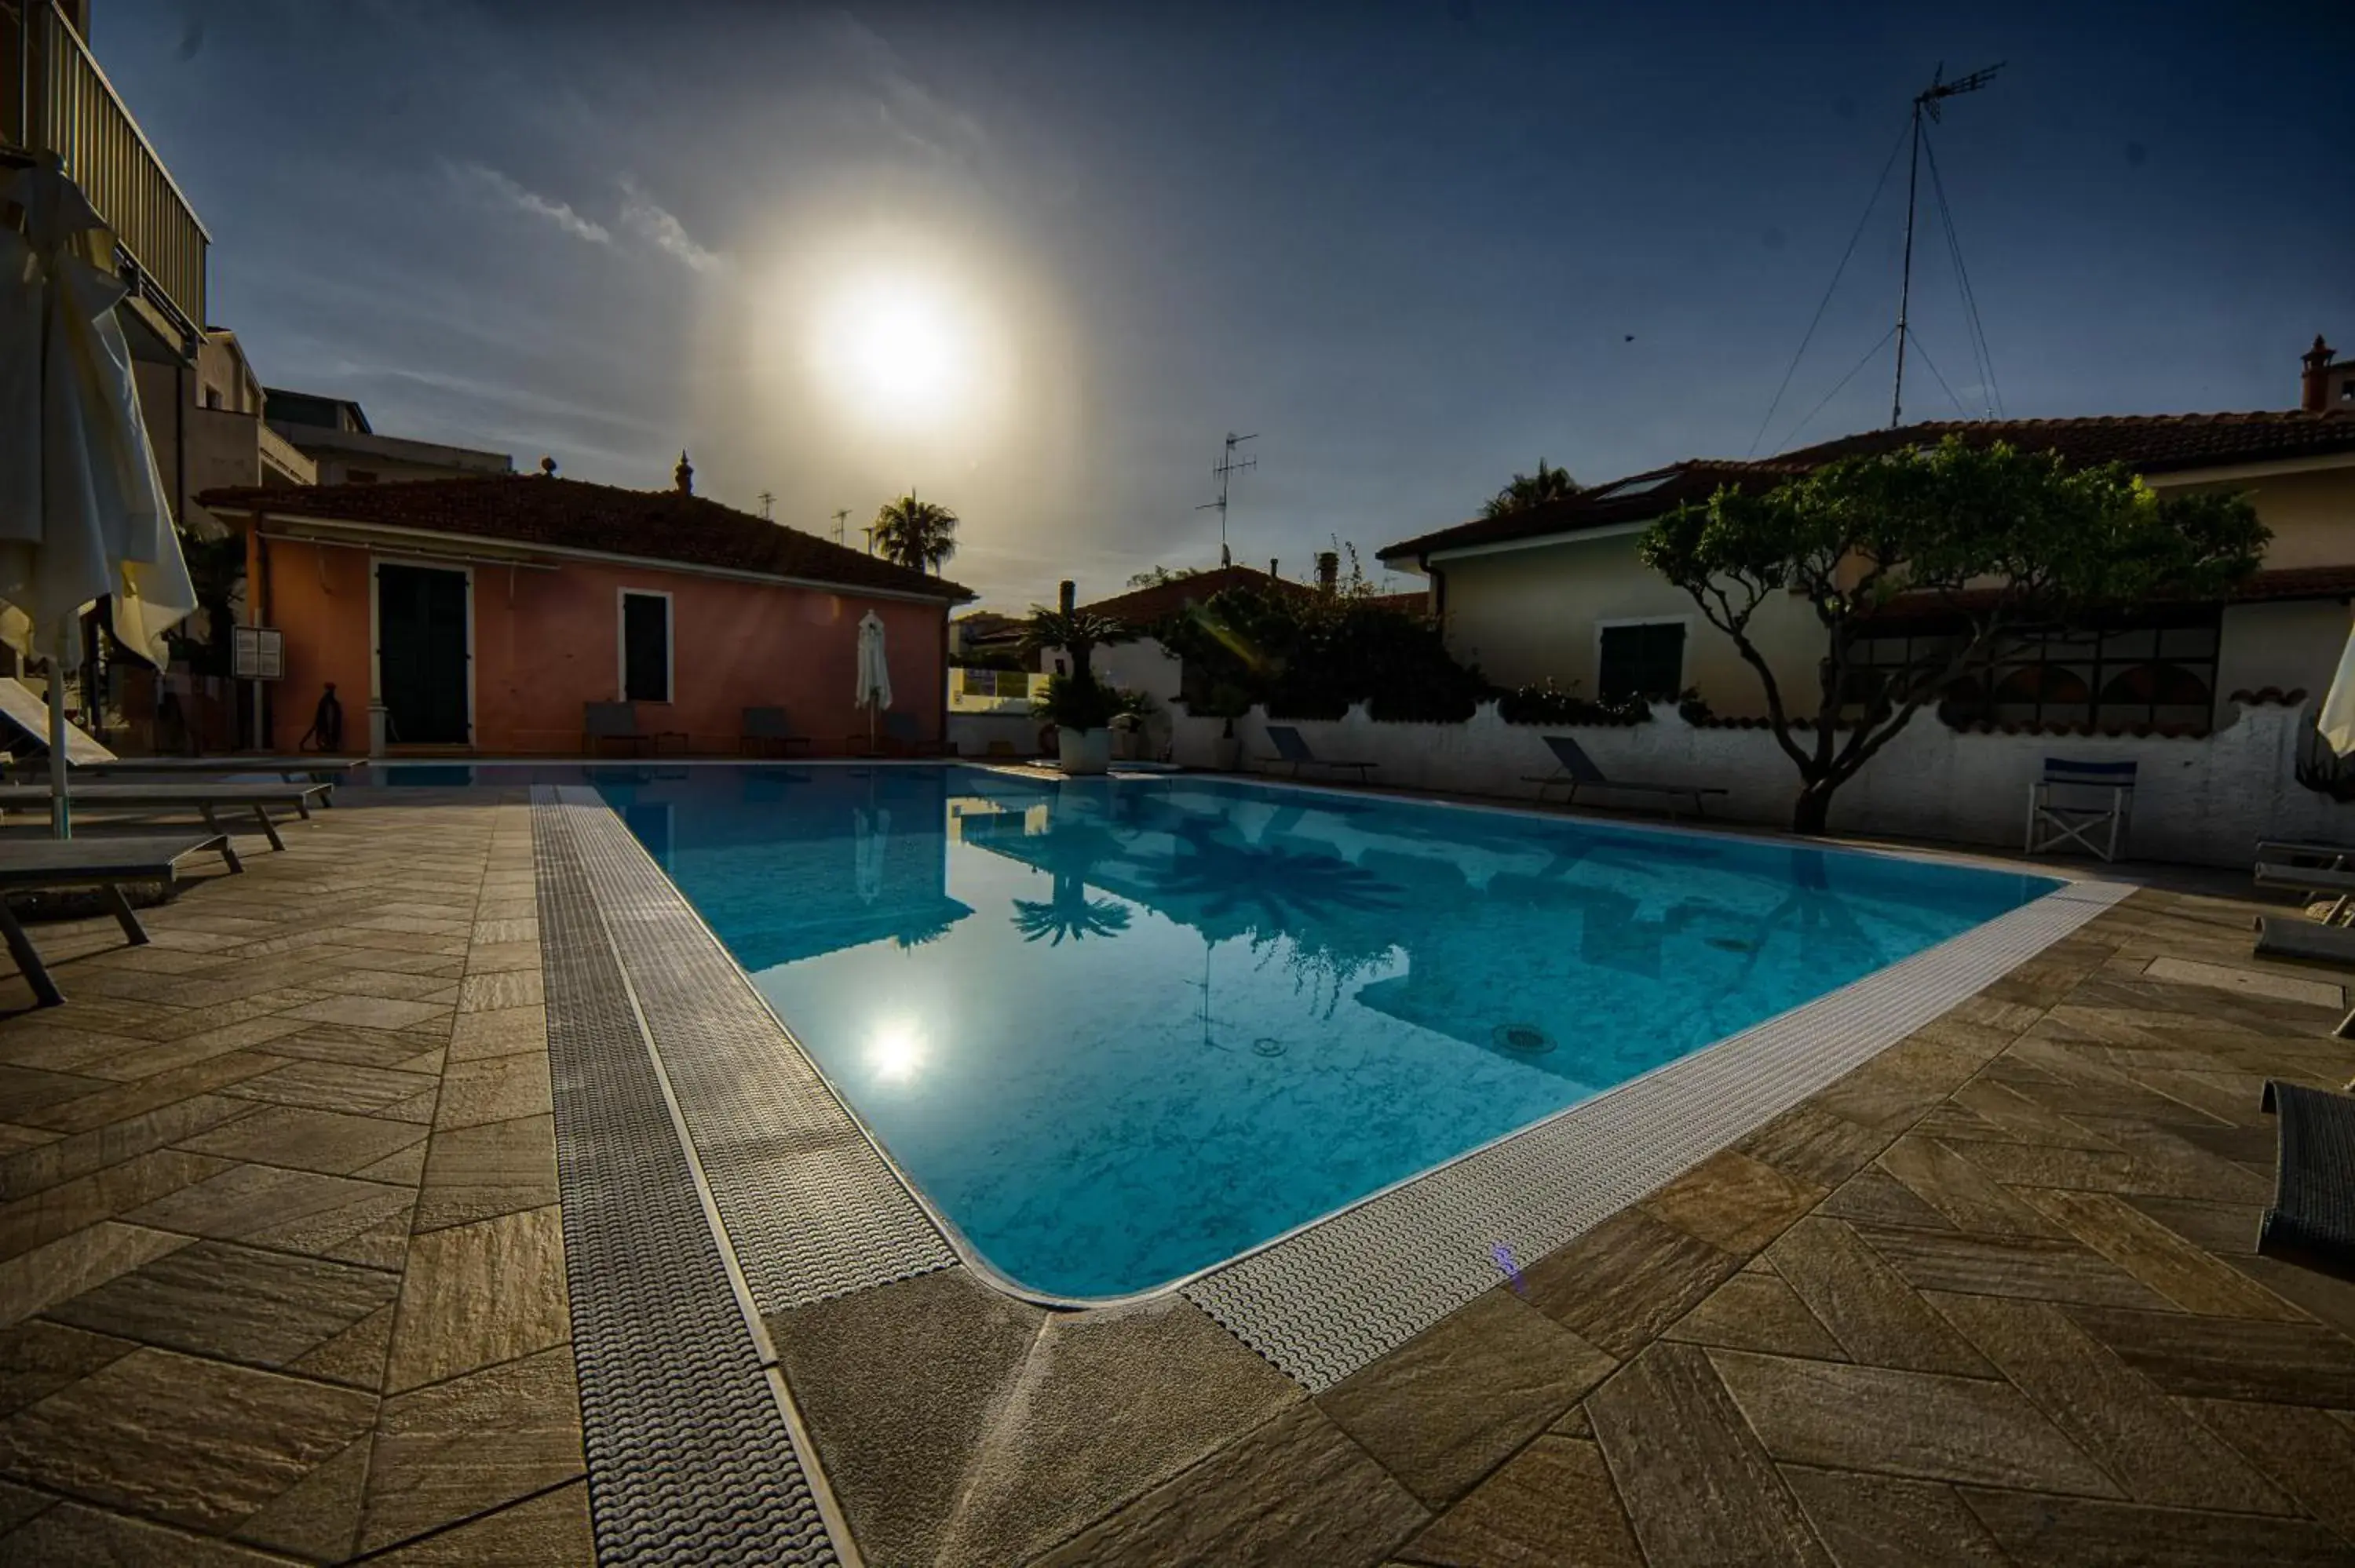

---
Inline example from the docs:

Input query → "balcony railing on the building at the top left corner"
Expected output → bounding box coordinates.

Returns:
[0,0,212,346]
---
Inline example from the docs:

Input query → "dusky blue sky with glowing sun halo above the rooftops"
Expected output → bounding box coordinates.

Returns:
[92,0,2355,607]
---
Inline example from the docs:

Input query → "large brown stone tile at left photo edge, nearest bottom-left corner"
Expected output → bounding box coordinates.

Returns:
[0,1349,374,1533]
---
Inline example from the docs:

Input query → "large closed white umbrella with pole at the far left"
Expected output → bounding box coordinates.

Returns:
[0,153,195,838]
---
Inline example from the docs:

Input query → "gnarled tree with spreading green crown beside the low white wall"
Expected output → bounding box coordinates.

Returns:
[1637,436,2270,833]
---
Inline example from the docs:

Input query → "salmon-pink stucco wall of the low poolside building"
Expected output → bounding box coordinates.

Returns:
[254,539,947,756]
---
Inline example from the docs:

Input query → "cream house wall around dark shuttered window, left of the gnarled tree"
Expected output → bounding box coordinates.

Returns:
[1434,534,1823,716]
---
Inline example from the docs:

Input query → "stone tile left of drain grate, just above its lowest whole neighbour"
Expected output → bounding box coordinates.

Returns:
[386,1205,570,1391]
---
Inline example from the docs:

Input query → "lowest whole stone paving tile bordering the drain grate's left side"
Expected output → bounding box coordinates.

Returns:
[360,1347,584,1552]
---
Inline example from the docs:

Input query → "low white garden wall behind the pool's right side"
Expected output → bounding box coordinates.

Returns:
[1175,704,2355,866]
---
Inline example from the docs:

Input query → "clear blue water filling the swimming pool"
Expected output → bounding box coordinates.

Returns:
[382,765,2056,1297]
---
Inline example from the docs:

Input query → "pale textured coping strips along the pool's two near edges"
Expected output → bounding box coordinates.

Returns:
[532,786,2131,1394]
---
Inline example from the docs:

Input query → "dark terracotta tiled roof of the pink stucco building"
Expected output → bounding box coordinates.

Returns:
[198,473,973,600]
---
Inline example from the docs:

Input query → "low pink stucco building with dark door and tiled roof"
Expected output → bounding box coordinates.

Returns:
[203,476,973,756]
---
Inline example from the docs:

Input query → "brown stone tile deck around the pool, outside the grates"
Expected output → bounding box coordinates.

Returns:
[0,789,2355,1568]
